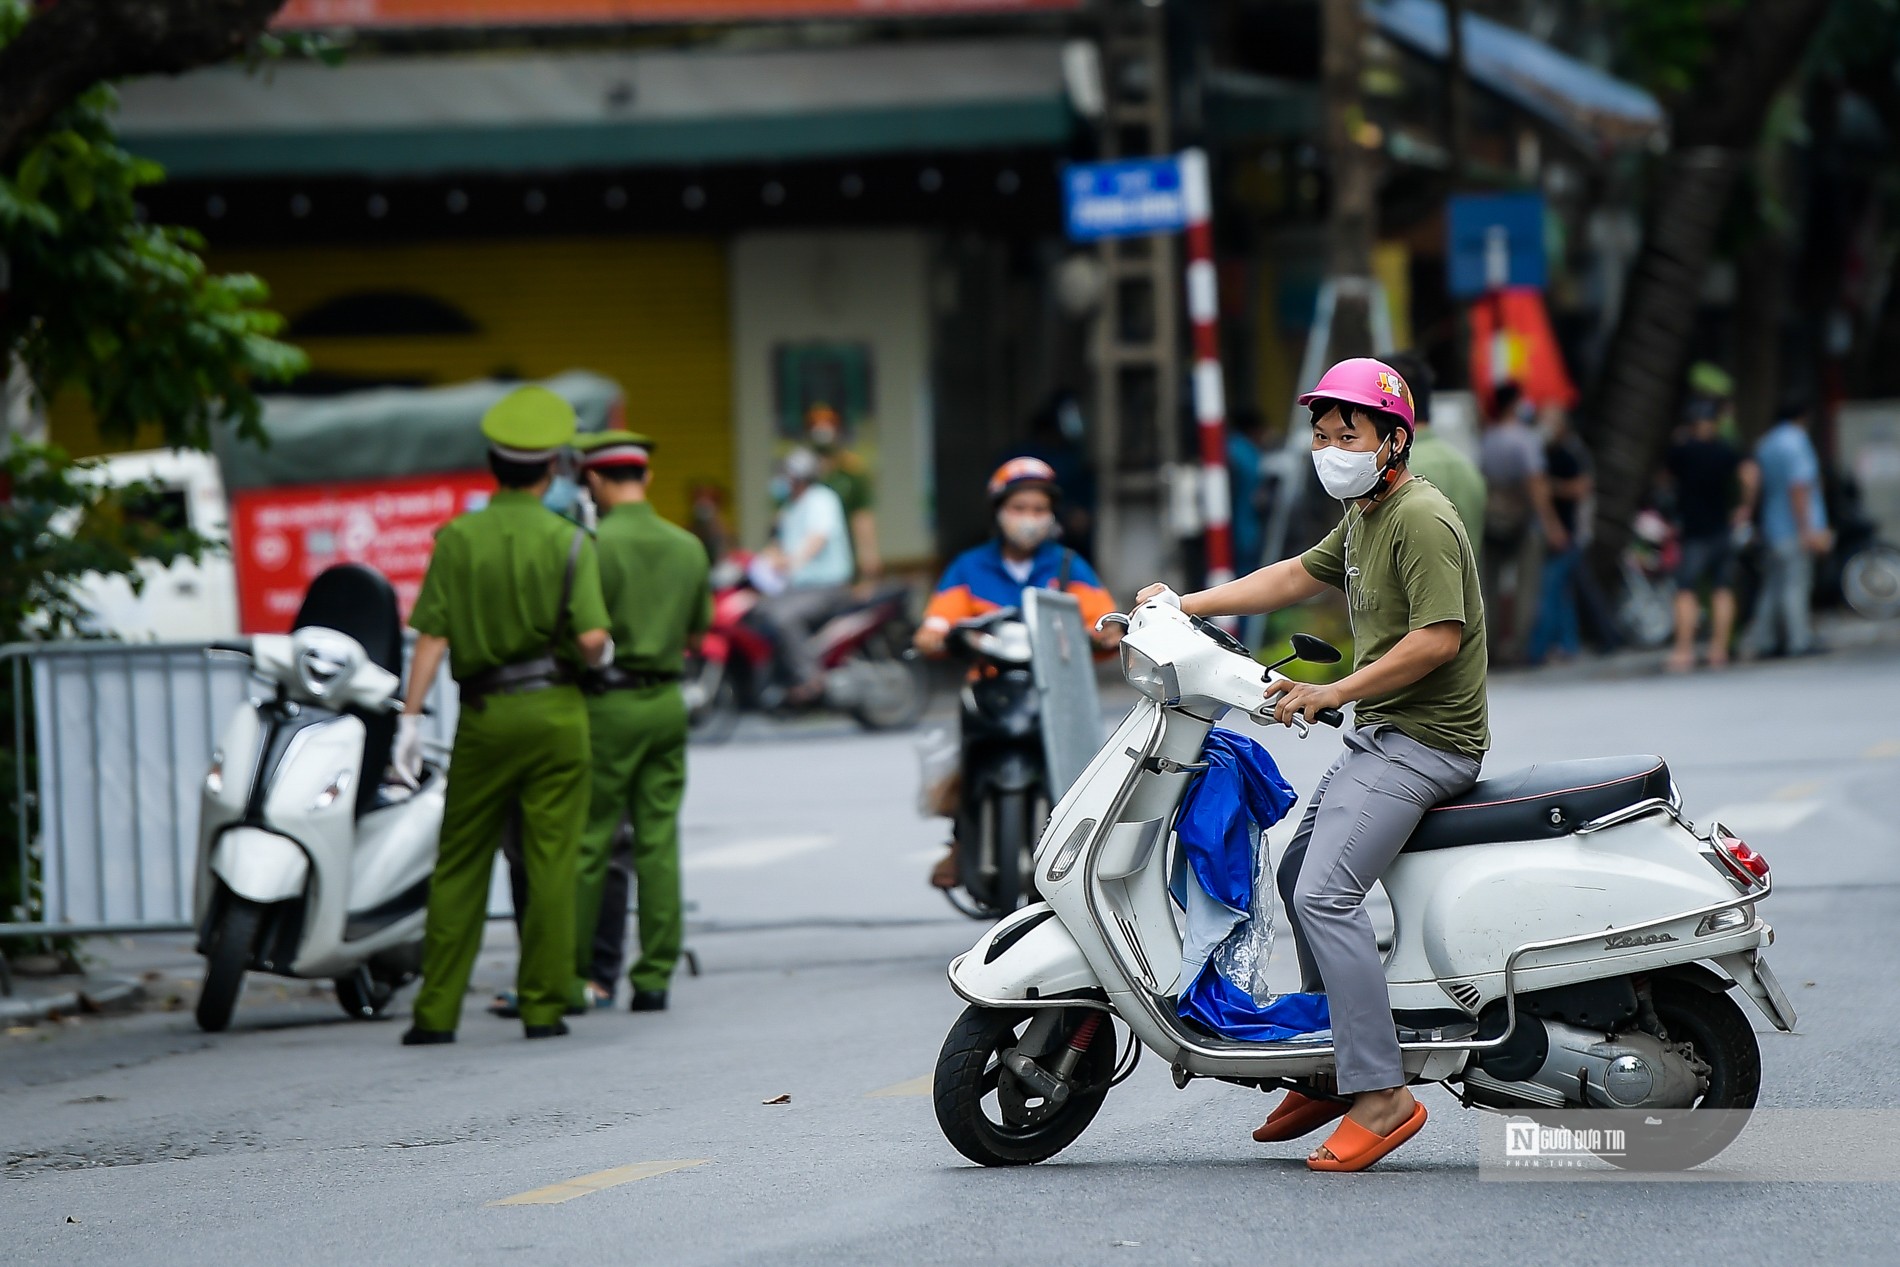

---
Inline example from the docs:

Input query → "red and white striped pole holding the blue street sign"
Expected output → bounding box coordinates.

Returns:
[1180,148,1233,585]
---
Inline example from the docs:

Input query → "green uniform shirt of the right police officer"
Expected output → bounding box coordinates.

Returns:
[595,501,713,672]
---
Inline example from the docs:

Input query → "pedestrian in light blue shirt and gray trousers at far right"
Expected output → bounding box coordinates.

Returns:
[1742,403,1834,657]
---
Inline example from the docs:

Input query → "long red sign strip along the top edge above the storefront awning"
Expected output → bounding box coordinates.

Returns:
[276,0,1081,28]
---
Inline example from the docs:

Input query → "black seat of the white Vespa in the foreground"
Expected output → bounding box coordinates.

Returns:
[1404,756,1670,853]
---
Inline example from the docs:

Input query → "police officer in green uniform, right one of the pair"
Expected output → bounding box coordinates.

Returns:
[574,431,713,1012]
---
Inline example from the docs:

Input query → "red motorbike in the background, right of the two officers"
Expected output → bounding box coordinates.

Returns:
[682,555,929,743]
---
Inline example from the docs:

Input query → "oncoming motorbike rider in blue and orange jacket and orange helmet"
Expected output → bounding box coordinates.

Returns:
[914,458,1121,889]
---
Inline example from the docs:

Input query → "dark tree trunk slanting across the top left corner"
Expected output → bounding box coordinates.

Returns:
[0,0,283,171]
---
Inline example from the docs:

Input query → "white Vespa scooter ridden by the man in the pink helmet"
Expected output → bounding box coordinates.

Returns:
[935,600,1796,1166]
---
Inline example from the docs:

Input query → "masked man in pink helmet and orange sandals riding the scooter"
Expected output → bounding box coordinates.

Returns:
[1138,357,1492,1170]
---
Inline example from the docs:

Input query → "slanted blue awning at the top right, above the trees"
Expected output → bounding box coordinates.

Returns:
[1366,0,1664,152]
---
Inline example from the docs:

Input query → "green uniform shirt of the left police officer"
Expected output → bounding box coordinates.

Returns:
[409,488,608,682]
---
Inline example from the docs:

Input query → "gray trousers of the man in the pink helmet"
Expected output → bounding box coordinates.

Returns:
[1279,726,1478,1094]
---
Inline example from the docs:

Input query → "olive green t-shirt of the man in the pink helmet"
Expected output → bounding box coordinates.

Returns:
[1300,479,1492,758]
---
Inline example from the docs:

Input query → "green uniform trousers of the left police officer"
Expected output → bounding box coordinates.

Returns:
[416,686,589,1030]
